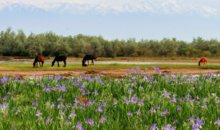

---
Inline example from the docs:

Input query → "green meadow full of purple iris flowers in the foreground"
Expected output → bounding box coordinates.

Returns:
[0,66,220,130]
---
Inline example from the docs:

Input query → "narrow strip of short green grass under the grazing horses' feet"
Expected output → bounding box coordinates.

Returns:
[0,63,220,70]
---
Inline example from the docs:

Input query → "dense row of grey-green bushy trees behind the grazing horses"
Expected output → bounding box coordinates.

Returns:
[0,27,220,57]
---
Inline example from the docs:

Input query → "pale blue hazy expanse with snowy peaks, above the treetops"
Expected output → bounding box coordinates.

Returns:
[0,0,220,42]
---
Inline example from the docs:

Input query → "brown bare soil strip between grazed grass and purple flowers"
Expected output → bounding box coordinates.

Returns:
[0,67,219,78]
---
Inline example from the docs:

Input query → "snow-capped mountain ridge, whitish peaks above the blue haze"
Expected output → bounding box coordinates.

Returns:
[0,0,220,17]
